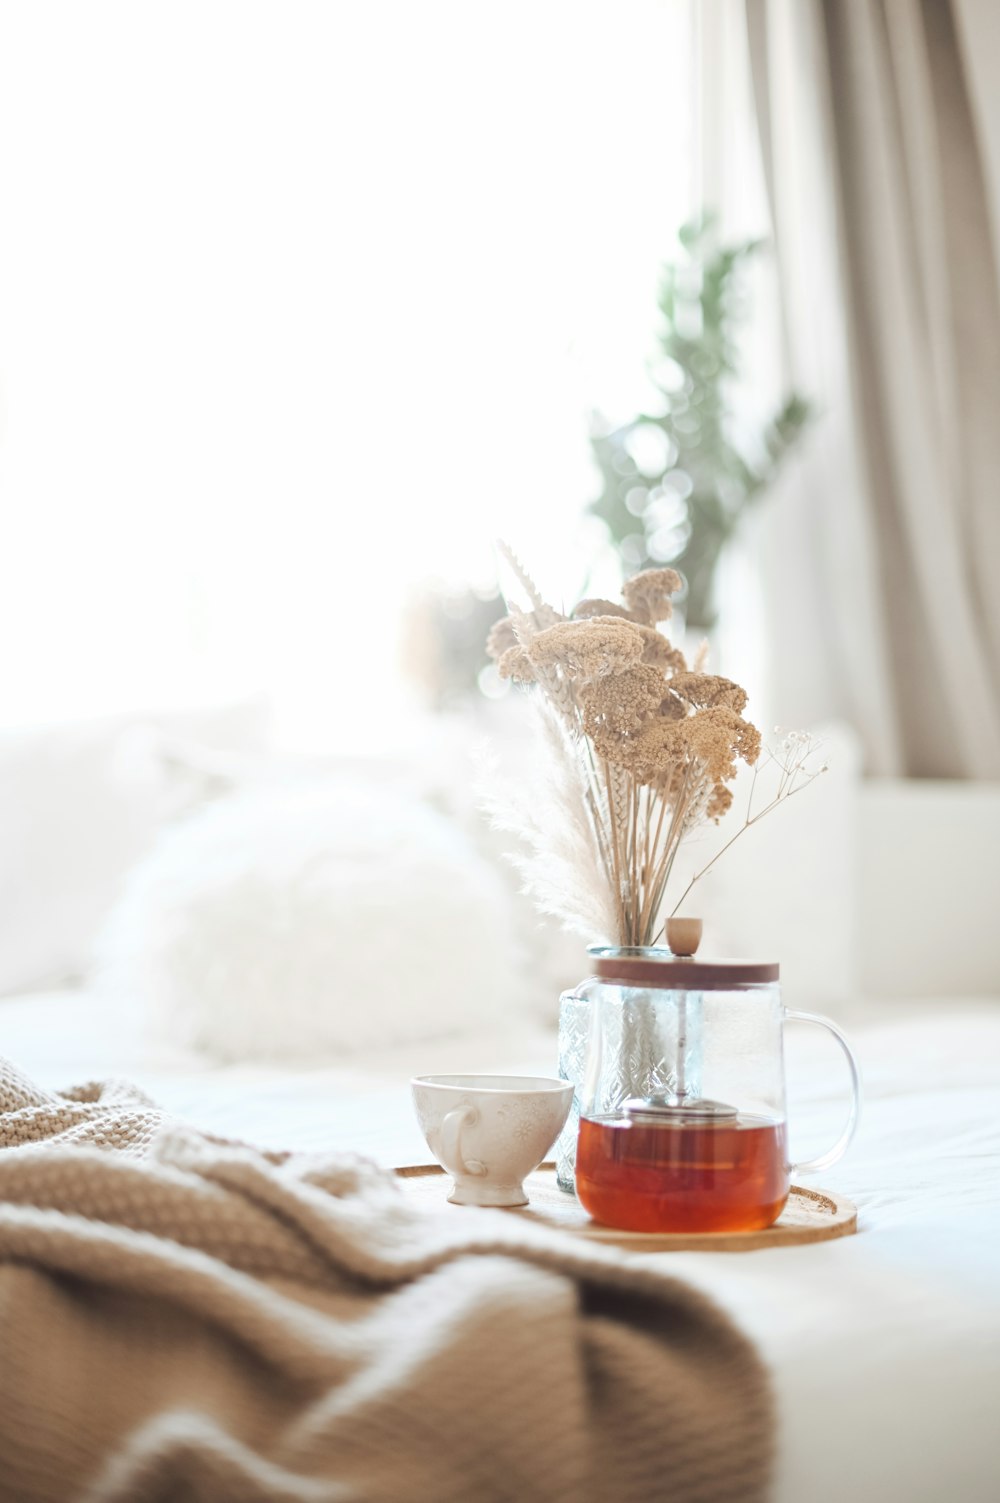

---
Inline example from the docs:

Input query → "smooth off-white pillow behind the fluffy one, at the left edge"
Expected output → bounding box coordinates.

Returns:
[0,700,266,995]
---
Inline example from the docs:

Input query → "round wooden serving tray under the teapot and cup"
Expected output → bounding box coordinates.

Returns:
[395,1163,857,1252]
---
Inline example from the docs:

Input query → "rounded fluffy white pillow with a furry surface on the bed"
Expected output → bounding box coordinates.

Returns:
[98,782,520,1061]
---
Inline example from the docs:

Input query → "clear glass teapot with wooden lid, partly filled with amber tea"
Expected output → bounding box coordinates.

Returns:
[558,948,860,1232]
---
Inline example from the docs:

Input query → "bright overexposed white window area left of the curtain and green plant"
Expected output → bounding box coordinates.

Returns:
[0,0,693,741]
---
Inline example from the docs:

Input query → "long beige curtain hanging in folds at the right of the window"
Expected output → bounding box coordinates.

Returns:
[736,0,1000,779]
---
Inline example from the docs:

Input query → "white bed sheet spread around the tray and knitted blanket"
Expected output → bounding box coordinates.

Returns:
[0,993,1000,1503]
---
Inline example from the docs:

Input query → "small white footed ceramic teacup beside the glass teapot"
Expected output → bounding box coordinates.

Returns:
[411,1075,573,1205]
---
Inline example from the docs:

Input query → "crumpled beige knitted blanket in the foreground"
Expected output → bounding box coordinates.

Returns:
[0,1061,773,1503]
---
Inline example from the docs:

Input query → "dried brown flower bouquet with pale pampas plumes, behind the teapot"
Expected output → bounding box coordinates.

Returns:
[484,547,824,945]
